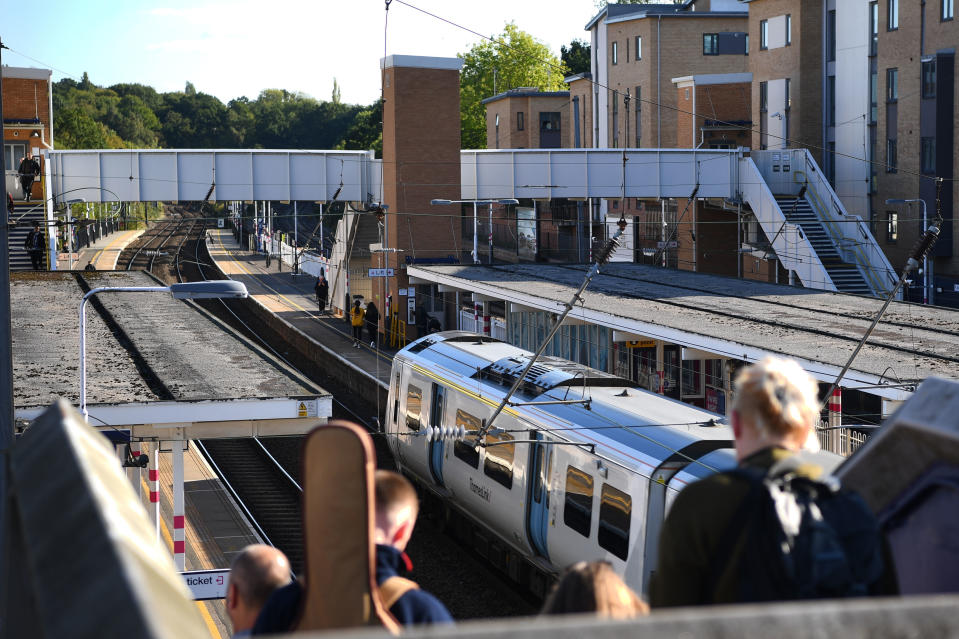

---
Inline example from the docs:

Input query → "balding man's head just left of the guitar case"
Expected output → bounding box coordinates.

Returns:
[226,544,290,633]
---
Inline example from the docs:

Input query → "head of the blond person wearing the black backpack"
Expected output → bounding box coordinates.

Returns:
[732,357,819,459]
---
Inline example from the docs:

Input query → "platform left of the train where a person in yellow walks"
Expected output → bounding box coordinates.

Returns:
[207,229,397,387]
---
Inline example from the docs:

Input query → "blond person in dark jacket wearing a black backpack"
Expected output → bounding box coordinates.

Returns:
[650,357,898,608]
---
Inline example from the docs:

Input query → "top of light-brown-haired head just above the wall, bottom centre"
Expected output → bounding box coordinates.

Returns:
[542,561,649,619]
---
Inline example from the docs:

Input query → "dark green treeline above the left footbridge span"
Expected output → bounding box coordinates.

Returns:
[53,73,383,150]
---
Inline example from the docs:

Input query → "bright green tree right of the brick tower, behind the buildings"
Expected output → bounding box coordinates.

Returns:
[459,22,567,149]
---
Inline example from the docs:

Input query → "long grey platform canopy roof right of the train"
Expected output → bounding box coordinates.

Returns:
[408,263,959,399]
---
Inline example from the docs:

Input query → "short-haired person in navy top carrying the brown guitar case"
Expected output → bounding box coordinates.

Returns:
[253,470,453,635]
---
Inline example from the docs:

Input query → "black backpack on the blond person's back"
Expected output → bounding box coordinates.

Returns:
[714,458,883,603]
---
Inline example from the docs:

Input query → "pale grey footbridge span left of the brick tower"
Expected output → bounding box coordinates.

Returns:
[47,149,382,202]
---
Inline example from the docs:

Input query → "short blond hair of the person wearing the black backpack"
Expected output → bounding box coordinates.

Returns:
[733,357,819,448]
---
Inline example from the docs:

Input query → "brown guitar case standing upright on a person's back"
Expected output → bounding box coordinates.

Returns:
[293,420,400,634]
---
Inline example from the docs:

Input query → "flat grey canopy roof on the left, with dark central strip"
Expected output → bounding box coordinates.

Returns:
[11,272,329,412]
